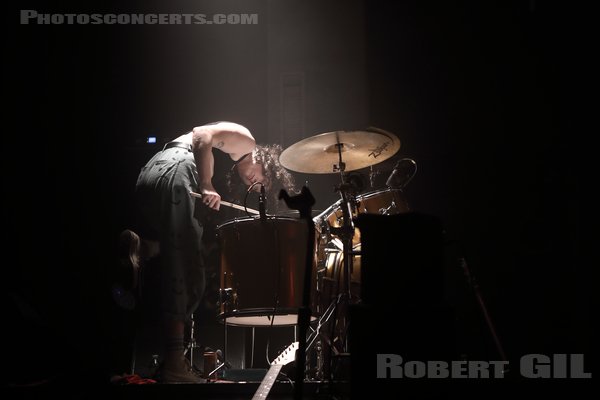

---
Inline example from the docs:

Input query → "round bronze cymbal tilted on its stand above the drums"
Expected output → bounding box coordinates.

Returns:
[279,128,400,174]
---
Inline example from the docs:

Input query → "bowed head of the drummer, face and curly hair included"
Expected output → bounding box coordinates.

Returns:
[228,144,294,196]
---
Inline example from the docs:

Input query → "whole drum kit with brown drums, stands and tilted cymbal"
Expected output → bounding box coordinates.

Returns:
[217,128,416,375]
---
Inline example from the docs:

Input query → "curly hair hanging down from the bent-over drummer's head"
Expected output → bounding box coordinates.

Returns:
[226,144,296,212]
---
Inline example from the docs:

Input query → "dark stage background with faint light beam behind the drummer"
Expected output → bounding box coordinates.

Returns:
[2,0,594,396]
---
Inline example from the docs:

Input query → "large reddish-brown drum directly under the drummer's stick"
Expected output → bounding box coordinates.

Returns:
[217,216,316,326]
